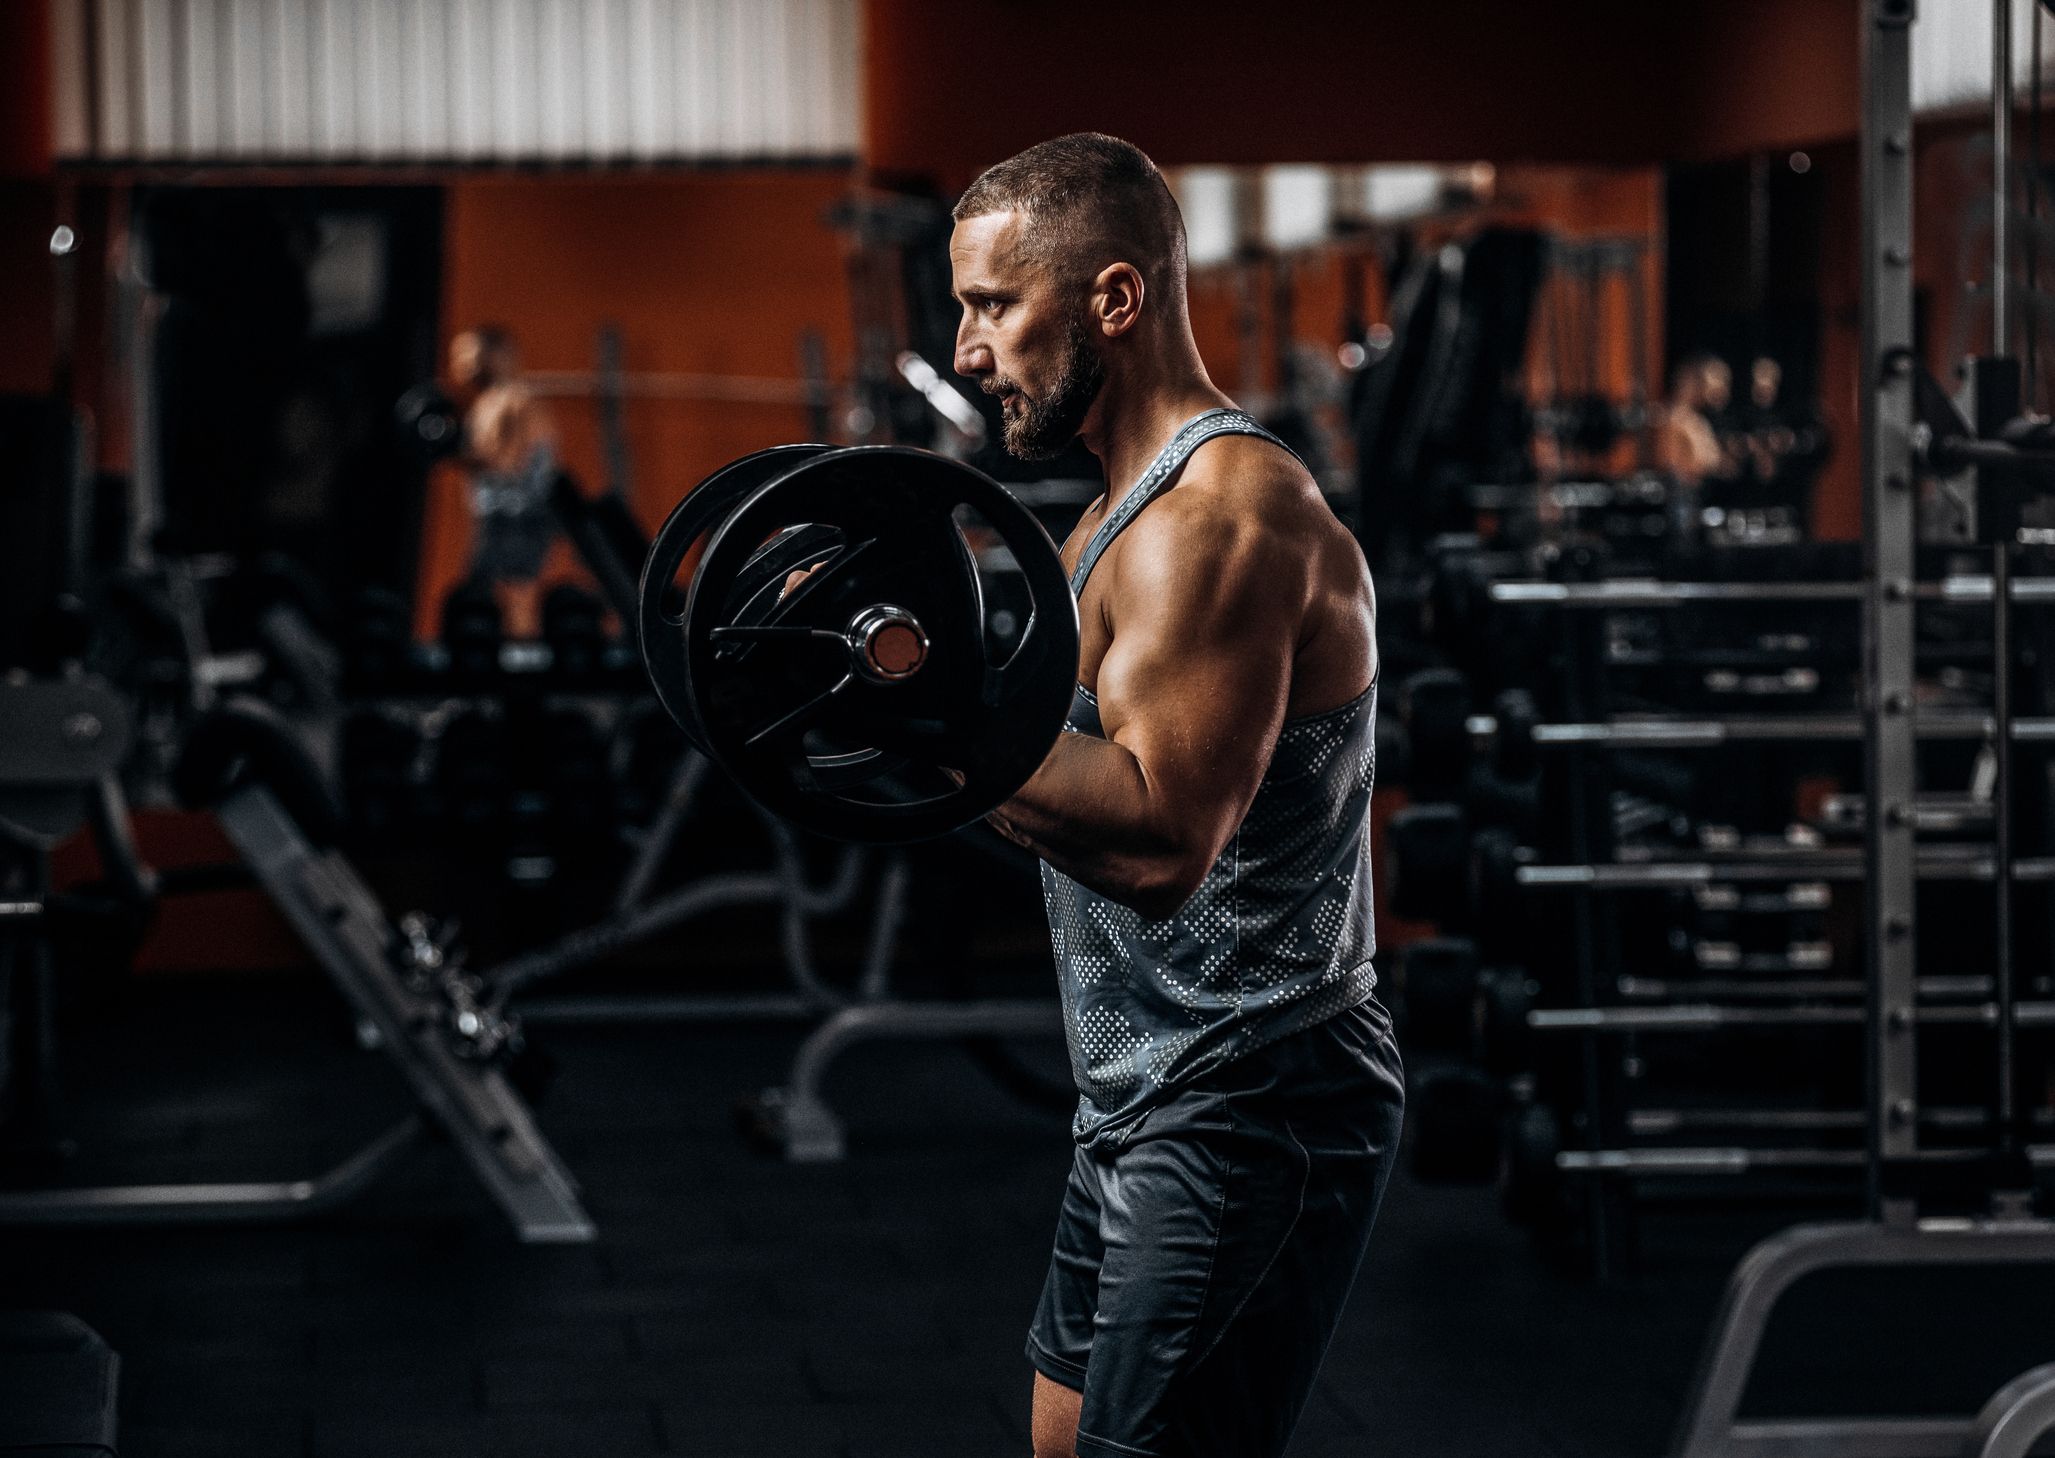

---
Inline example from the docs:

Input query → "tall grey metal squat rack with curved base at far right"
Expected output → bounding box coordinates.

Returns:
[1675,0,2055,1458]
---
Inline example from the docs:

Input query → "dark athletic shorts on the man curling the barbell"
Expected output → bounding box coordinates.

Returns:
[1028,997,1406,1458]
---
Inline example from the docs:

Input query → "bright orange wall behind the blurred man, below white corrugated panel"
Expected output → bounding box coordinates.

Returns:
[417,171,853,631]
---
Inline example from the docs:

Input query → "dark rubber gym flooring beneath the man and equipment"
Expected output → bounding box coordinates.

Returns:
[0,975,2055,1458]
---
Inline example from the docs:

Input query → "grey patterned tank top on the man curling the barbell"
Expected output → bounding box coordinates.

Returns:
[1042,409,1377,1147]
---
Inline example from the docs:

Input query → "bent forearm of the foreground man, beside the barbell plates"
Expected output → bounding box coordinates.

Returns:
[986,734,1192,913]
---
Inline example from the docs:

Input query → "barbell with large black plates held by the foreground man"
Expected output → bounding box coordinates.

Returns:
[637,444,1079,845]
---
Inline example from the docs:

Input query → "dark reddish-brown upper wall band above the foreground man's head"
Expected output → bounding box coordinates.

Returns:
[865,0,1858,187]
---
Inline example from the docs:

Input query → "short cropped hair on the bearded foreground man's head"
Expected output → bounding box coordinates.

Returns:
[954,132,1186,298]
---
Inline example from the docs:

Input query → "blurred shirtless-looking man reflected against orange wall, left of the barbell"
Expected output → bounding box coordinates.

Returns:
[450,325,557,637]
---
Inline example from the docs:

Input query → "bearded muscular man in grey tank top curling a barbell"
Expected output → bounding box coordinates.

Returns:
[949,134,1404,1458]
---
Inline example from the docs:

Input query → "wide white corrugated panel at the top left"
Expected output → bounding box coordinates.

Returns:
[51,0,861,162]
